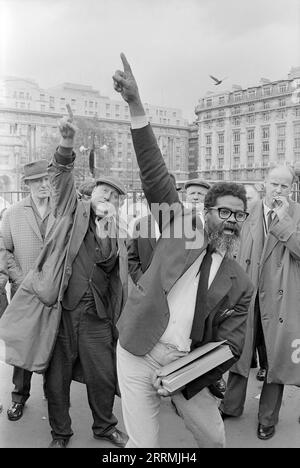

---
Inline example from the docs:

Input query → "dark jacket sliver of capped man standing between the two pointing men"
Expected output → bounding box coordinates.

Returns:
[127,215,156,284]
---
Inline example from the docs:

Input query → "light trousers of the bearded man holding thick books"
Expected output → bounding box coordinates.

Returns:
[117,343,225,448]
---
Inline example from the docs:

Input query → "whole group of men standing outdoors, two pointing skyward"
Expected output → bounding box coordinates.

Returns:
[0,54,300,448]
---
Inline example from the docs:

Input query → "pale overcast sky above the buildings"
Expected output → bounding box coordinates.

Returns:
[0,0,300,120]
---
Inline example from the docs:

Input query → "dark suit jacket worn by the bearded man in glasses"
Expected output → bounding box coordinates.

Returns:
[117,125,253,398]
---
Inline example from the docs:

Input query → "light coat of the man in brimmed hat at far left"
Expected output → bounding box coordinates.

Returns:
[0,196,55,291]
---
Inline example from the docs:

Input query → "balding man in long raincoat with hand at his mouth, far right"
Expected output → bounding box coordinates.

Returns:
[221,166,300,440]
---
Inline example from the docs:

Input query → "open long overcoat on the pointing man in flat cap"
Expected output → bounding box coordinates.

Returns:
[0,148,127,379]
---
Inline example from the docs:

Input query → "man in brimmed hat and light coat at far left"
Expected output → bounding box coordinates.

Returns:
[1,159,55,421]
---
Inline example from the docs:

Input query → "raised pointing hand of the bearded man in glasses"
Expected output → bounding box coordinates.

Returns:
[113,53,140,104]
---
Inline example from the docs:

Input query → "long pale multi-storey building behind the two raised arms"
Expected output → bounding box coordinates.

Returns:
[0,77,189,191]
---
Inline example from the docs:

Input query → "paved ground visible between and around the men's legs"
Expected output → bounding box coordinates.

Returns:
[0,363,300,449]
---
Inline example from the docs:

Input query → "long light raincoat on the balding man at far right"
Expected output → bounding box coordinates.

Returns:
[231,197,300,385]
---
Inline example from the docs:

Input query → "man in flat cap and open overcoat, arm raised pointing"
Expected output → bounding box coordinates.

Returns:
[0,118,127,448]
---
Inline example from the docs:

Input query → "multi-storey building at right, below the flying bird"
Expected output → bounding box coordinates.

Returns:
[195,67,300,182]
